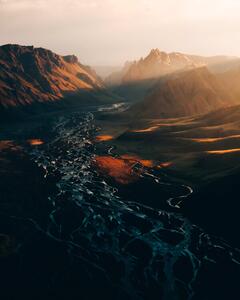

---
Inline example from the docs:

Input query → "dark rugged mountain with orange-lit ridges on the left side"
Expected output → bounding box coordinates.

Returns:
[0,44,108,109]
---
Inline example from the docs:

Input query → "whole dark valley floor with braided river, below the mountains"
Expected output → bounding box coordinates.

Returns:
[0,106,240,300]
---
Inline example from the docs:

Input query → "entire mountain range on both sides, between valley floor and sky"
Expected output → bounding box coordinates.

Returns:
[0,44,240,118]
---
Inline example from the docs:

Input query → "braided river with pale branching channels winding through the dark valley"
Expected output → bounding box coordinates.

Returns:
[28,113,240,300]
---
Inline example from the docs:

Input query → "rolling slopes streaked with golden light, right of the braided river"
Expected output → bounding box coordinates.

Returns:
[95,107,240,186]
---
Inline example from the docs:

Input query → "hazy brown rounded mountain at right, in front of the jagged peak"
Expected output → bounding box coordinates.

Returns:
[129,67,240,118]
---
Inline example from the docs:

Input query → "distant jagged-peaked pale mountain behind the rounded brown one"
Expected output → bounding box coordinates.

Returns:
[105,49,236,102]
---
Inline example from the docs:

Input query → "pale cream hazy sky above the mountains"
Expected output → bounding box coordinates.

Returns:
[0,0,240,65]
